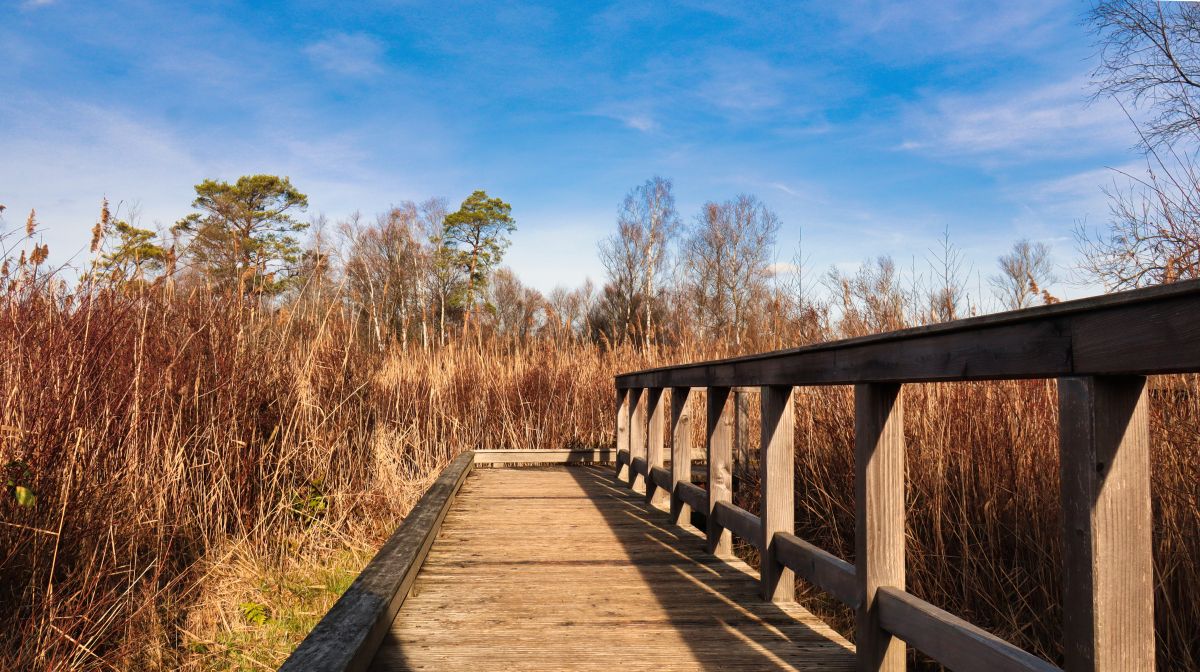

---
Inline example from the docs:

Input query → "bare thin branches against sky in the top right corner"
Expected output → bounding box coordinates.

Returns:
[1088,0,1200,146]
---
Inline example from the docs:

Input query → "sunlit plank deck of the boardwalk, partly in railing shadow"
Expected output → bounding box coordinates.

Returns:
[372,467,854,672]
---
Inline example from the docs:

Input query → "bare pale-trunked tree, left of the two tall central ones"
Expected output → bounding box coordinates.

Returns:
[600,176,679,346]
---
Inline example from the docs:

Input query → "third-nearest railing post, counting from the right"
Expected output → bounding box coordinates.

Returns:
[758,385,796,602]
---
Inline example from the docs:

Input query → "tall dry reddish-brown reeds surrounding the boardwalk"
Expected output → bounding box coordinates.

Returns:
[0,284,1200,670]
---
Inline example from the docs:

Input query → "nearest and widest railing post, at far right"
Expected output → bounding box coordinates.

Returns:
[1058,376,1154,672]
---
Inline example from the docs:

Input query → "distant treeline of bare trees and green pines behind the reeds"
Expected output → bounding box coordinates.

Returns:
[11,175,1080,360]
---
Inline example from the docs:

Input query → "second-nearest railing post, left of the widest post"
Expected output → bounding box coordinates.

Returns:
[854,383,905,672]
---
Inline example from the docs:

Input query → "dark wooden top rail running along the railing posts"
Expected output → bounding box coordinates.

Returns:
[617,281,1200,389]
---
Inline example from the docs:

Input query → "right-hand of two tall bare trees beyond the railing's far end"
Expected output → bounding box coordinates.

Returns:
[684,194,779,346]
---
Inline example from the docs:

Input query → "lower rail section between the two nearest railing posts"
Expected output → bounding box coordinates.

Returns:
[875,587,1062,672]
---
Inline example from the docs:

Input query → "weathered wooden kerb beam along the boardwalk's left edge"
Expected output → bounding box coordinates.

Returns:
[280,452,474,672]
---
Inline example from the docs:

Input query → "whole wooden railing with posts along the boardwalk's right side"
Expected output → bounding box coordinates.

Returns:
[616,276,1200,672]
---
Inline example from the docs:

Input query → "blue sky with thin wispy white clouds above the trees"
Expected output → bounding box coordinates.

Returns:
[0,0,1140,296]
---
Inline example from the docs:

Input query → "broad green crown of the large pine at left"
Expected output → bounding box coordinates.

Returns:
[173,175,308,294]
